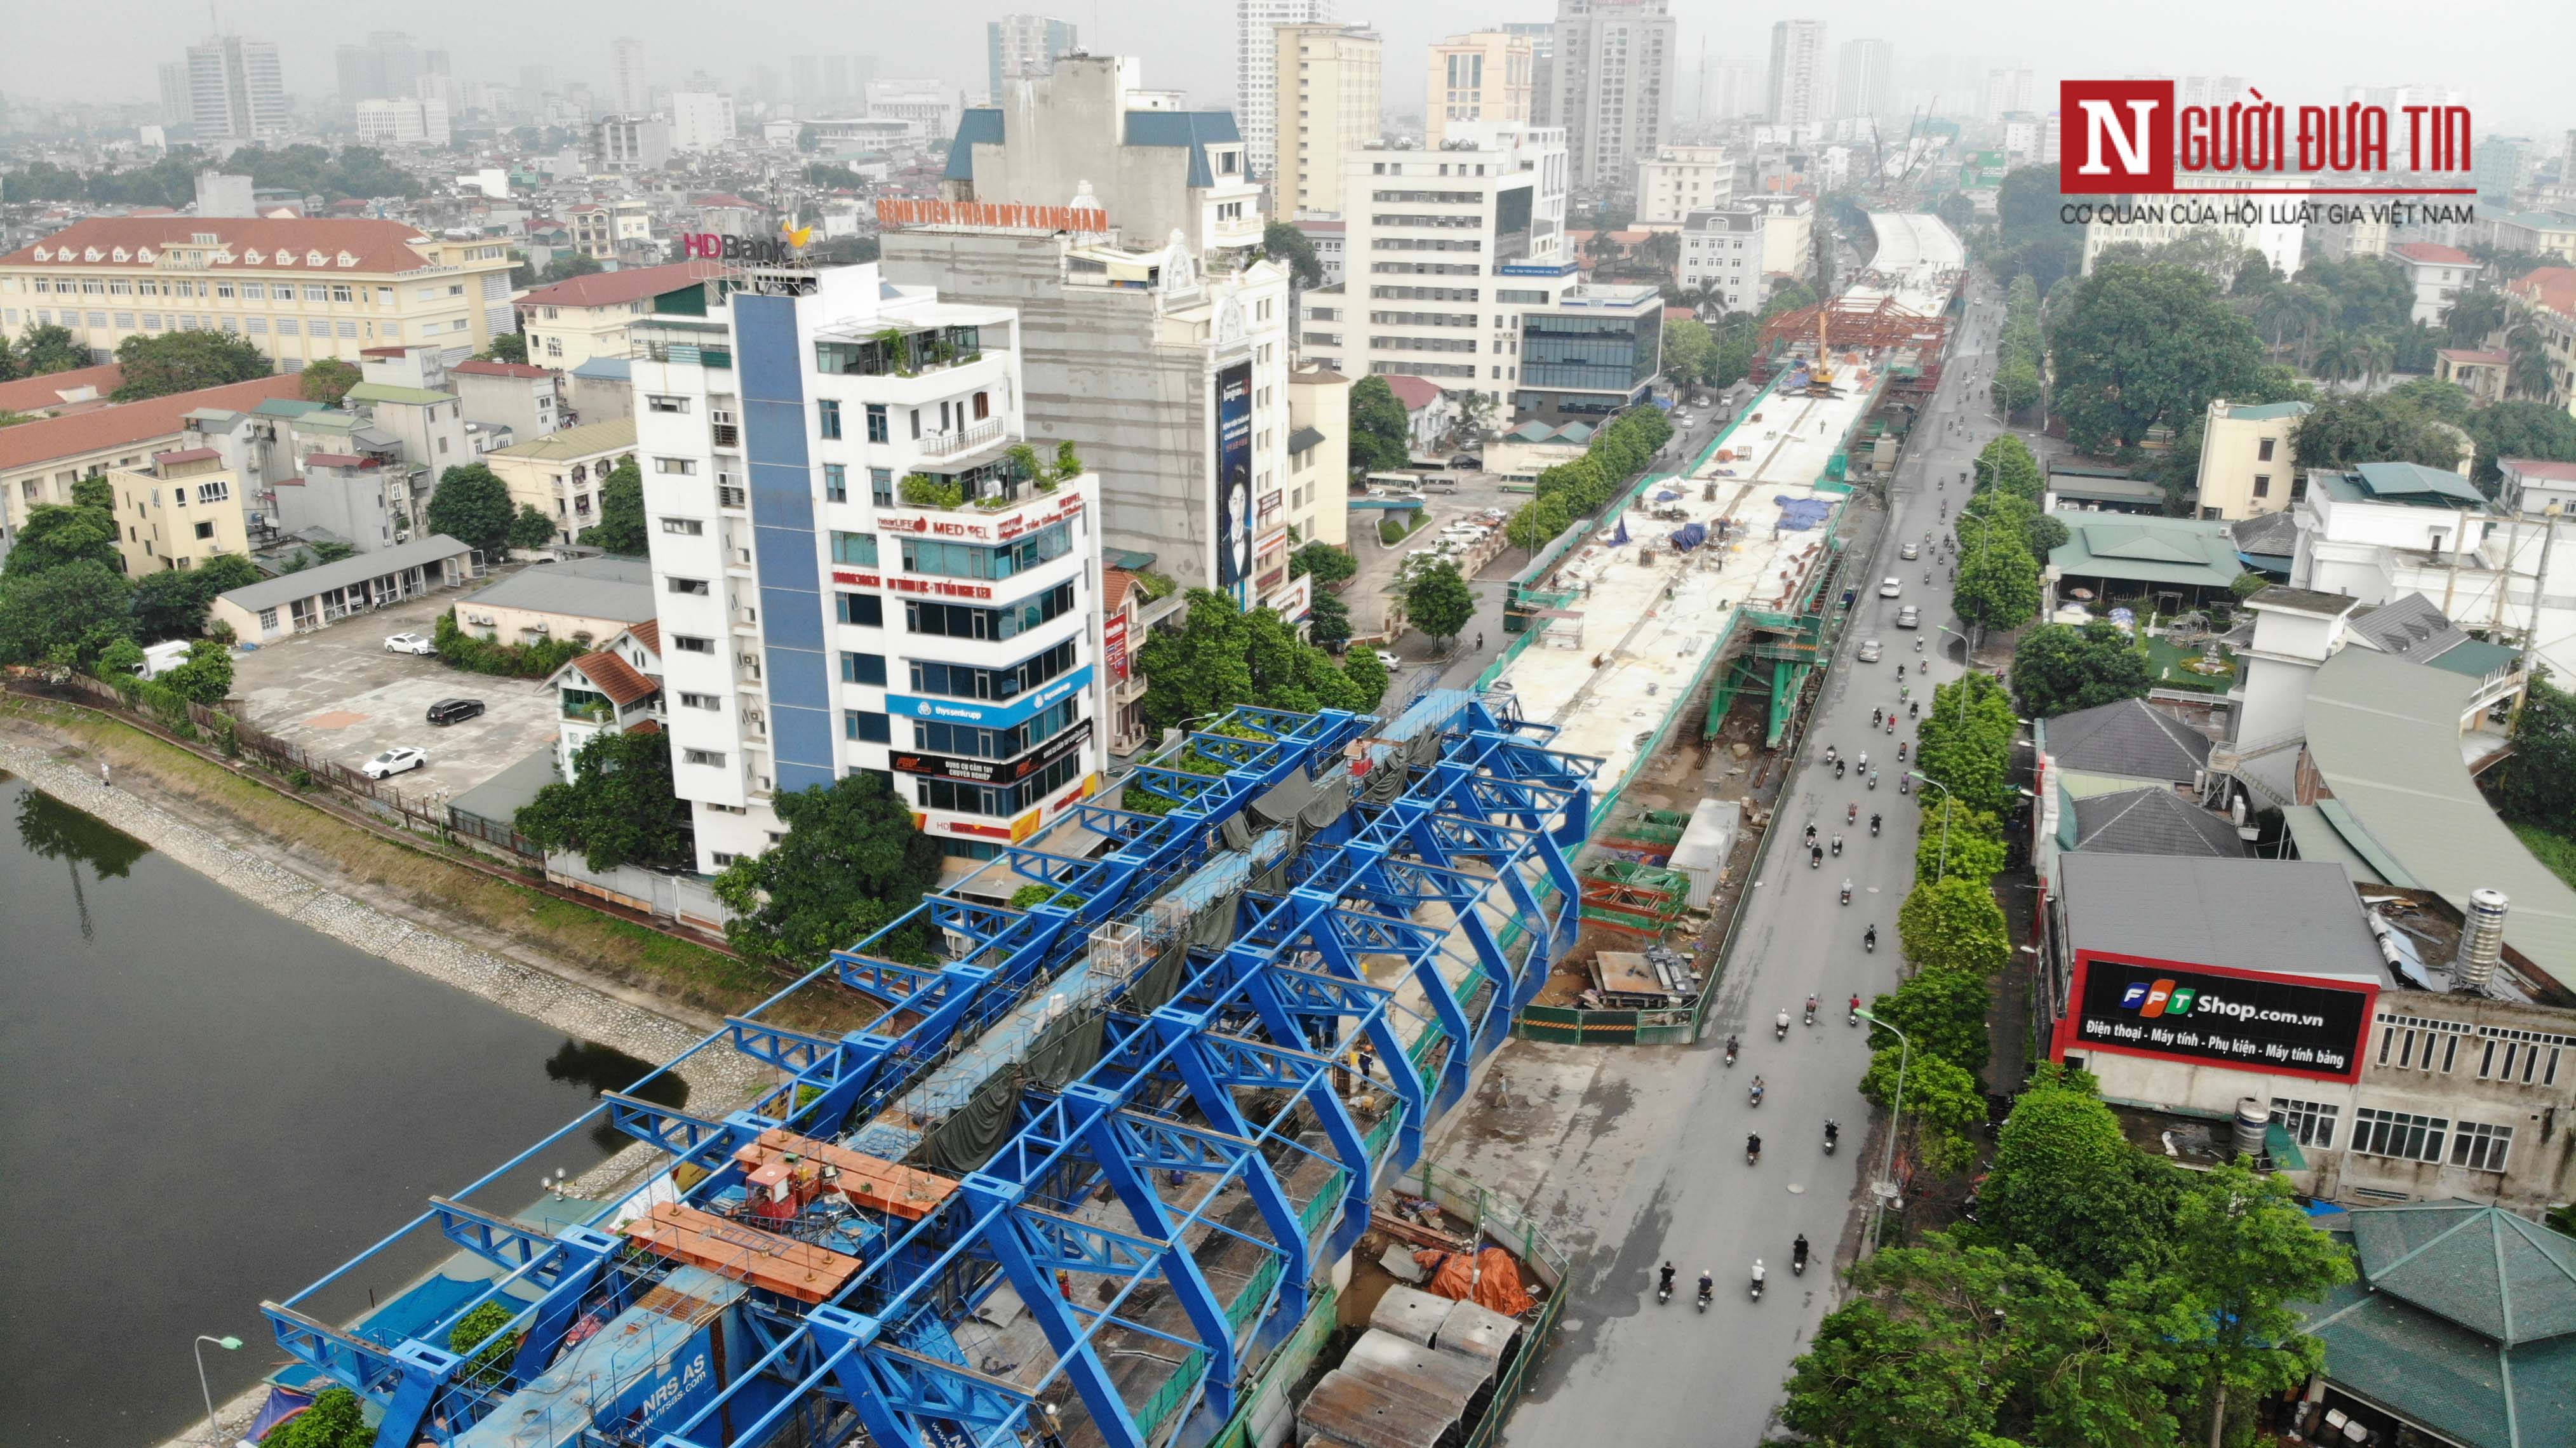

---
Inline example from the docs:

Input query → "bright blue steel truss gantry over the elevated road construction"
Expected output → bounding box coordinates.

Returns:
[263,693,1595,1448]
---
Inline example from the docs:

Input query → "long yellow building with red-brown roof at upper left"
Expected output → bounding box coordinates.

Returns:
[0,217,510,371]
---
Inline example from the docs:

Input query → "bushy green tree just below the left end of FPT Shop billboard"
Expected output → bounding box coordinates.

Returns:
[1978,1067,2177,1294]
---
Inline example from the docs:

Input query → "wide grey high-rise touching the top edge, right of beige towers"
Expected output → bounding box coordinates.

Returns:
[1551,0,1677,191]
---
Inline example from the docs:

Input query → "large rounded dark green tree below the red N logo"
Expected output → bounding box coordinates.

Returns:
[2048,260,2288,451]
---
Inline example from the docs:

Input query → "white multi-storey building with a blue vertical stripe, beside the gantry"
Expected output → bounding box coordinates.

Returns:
[634,263,1103,871]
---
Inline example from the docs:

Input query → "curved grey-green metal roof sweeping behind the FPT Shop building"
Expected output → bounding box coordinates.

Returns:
[2308,649,2576,989]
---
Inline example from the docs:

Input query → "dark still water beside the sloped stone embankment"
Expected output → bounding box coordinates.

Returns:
[0,773,678,1448]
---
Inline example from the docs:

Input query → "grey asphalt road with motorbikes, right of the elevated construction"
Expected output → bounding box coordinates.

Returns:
[1494,267,2002,1448]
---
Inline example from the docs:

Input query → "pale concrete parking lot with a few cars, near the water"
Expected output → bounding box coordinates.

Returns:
[232,579,554,796]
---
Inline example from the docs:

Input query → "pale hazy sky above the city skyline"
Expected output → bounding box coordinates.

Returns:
[20,0,2576,134]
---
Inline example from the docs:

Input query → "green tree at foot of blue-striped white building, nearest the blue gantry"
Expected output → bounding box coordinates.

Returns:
[716,773,940,961]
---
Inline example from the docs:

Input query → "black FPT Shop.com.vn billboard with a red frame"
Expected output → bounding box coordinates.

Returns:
[2051,951,2380,1082]
